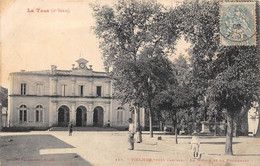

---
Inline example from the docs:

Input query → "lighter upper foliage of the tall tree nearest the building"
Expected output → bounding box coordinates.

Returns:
[92,0,178,68]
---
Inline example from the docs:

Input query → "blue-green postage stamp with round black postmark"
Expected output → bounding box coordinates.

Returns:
[220,2,256,46]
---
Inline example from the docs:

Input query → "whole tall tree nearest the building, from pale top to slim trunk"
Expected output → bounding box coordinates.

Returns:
[92,0,178,137]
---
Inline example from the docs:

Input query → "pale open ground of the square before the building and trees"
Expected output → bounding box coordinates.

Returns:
[0,131,260,166]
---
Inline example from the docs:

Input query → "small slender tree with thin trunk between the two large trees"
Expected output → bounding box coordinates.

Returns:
[154,56,195,144]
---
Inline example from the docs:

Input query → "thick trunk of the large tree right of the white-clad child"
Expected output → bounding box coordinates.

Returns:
[225,114,233,155]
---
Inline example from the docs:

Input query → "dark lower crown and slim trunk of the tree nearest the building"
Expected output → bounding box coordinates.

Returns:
[112,56,174,139]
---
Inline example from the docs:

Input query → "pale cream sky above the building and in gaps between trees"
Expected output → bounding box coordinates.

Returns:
[0,0,189,88]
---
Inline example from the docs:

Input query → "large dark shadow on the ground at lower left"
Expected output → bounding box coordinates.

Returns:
[0,135,91,166]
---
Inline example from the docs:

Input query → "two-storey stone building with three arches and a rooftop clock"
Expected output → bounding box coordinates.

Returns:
[8,58,144,128]
